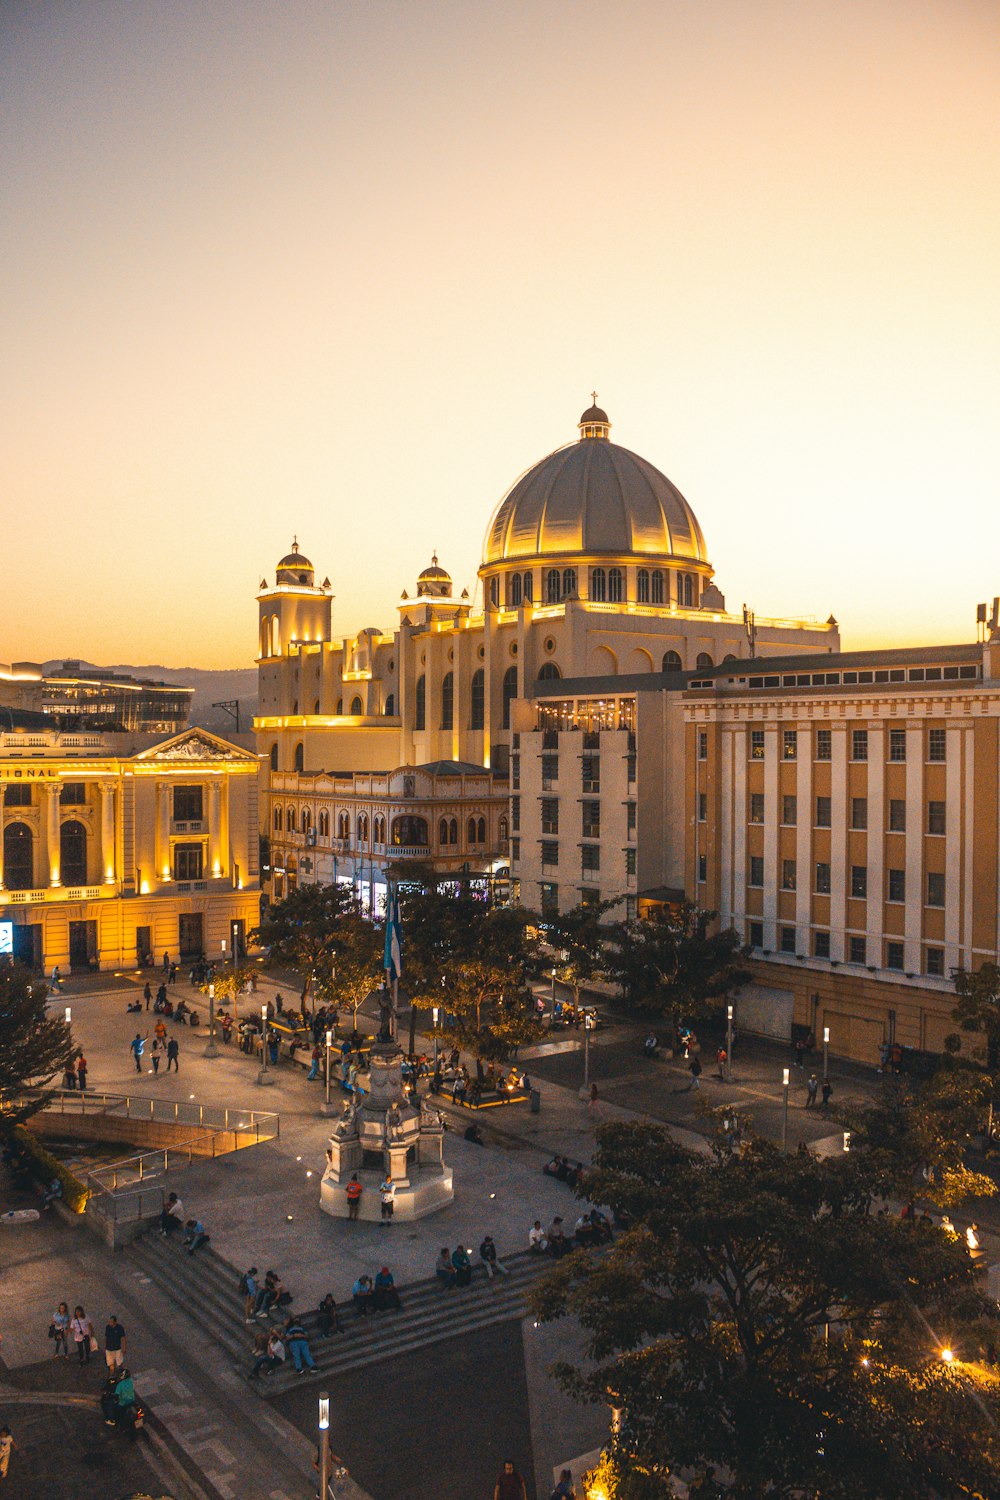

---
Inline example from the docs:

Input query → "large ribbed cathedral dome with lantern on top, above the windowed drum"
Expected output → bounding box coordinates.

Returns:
[483,404,708,567]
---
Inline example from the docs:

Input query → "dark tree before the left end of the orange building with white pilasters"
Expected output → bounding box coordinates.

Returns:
[607,902,750,1025]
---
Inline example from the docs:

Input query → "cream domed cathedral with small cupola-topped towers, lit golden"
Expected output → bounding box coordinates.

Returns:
[255,405,840,900]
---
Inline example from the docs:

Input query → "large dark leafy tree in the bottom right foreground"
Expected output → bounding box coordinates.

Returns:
[534,1124,1000,1500]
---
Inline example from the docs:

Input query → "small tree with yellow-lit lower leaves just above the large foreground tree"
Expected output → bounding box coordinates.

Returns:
[844,1064,997,1209]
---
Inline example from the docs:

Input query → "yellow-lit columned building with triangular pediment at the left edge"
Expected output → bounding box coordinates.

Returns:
[0,723,259,972]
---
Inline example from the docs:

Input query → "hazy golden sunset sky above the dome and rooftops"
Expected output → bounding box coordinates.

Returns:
[0,0,1000,668]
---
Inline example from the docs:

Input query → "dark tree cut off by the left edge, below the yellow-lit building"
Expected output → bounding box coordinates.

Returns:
[0,960,75,1137]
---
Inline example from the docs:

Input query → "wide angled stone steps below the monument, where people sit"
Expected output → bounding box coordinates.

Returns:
[126,1232,549,1397]
